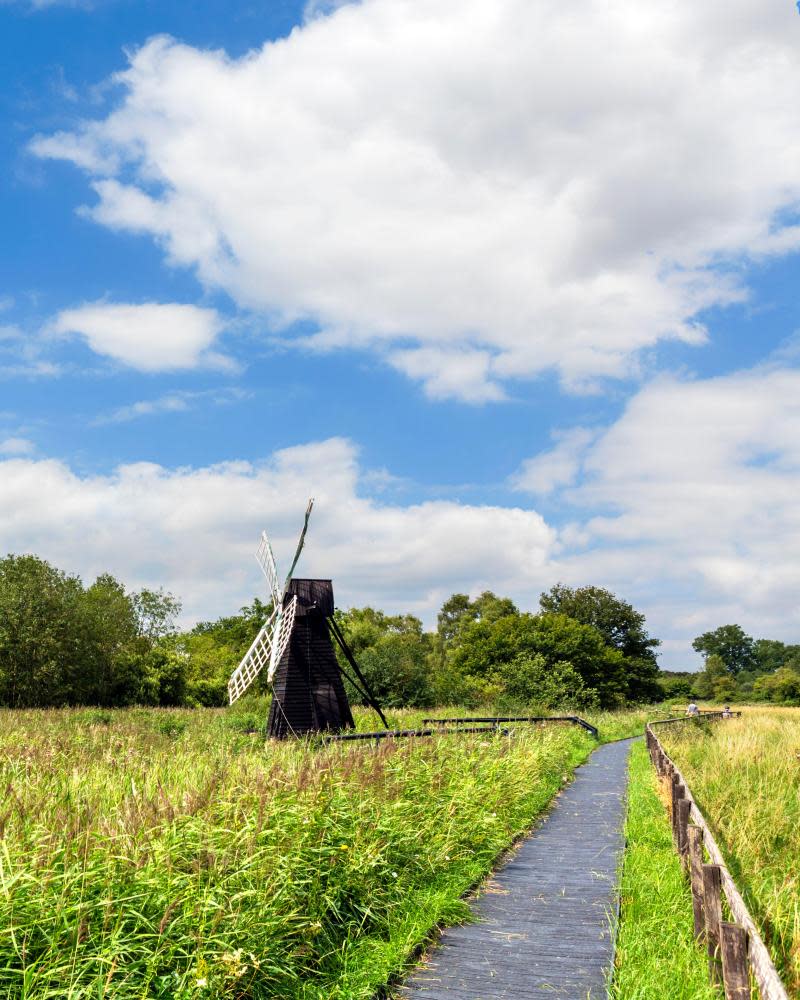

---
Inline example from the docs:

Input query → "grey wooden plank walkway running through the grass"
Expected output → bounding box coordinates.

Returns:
[395,740,631,1000]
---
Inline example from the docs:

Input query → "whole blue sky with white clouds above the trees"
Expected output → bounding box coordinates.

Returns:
[0,0,800,669]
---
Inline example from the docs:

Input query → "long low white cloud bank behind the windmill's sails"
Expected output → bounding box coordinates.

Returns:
[0,438,554,621]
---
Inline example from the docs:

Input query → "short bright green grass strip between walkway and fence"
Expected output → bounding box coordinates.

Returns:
[611,742,722,1000]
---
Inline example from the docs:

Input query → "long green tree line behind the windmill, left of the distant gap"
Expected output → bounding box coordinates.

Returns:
[0,555,665,711]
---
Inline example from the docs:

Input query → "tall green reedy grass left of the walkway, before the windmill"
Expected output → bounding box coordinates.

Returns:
[0,709,593,1000]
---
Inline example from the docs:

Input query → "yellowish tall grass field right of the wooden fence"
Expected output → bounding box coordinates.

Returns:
[659,708,800,996]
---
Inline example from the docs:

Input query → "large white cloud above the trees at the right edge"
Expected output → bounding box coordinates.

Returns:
[517,364,800,664]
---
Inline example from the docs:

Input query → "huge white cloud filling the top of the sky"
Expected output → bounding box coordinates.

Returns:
[33,0,800,401]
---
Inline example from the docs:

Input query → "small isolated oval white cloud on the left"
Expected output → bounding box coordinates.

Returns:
[52,302,231,372]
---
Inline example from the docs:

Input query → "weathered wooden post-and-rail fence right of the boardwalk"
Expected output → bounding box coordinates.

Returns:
[645,712,789,1000]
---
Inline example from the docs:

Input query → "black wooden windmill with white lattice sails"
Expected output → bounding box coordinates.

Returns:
[228,500,387,738]
